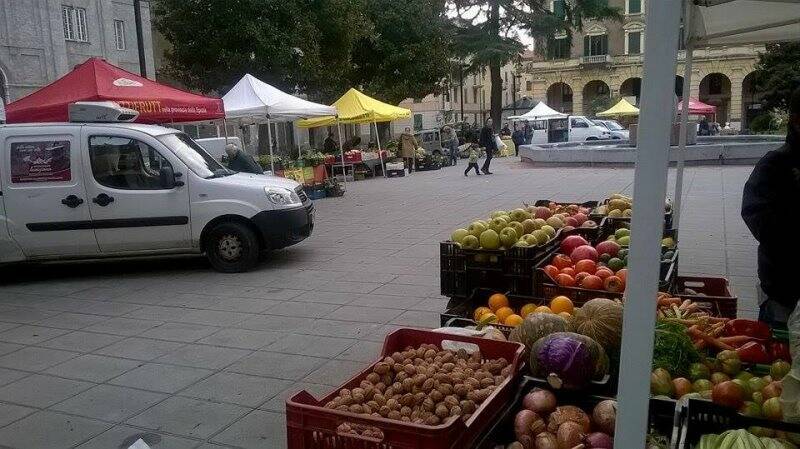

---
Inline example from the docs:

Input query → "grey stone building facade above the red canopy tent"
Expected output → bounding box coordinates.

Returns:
[0,0,154,104]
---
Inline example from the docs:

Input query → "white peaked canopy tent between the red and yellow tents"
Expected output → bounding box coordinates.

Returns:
[222,73,344,174]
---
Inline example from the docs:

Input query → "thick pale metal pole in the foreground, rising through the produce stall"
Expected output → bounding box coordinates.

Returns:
[614,0,685,449]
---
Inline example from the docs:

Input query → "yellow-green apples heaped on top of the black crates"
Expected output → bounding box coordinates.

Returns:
[450,209,564,250]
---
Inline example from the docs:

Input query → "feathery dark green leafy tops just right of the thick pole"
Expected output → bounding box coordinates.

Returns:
[653,321,701,378]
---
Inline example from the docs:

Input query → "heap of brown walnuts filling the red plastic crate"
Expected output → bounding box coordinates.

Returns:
[325,344,512,426]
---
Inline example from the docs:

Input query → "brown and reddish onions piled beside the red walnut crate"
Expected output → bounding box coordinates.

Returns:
[505,388,617,449]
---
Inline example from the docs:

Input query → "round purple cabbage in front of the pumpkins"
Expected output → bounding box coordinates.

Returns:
[536,333,595,389]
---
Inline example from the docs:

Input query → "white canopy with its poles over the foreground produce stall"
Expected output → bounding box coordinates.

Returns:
[614,0,800,449]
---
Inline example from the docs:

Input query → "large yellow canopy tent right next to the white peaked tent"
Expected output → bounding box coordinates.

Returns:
[297,88,411,177]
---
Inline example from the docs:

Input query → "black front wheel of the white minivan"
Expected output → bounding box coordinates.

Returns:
[205,222,259,273]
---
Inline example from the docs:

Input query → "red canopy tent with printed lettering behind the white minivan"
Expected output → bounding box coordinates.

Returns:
[6,58,225,123]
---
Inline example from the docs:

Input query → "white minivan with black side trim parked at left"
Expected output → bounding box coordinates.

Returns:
[0,108,314,272]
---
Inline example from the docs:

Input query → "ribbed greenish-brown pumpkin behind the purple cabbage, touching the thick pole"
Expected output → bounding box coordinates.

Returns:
[572,298,622,353]
